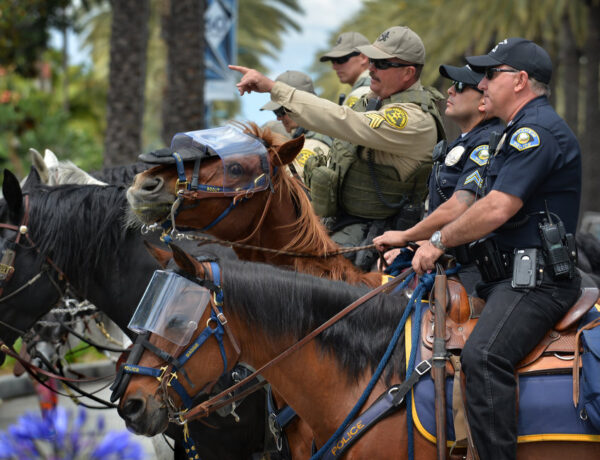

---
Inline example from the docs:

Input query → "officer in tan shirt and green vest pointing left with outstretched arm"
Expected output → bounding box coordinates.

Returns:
[230,26,444,267]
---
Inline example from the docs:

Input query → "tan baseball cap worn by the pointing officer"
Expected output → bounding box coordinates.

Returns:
[356,26,425,64]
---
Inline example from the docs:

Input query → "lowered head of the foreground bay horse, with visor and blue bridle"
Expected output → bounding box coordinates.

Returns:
[113,245,239,436]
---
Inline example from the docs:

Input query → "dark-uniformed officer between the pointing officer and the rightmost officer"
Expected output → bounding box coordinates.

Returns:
[373,65,504,292]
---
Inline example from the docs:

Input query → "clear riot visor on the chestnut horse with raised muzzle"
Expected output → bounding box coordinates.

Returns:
[171,126,270,195]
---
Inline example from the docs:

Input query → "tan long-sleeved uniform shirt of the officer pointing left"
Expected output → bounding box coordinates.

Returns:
[271,82,437,180]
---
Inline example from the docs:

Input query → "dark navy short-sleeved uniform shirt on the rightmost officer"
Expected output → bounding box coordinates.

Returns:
[485,96,581,251]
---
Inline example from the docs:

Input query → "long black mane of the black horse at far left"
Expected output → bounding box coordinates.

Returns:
[28,184,132,294]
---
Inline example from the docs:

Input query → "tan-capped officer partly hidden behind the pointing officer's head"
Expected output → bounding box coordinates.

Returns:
[319,32,371,107]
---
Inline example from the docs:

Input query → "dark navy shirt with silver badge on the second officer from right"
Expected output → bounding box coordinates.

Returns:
[429,118,504,212]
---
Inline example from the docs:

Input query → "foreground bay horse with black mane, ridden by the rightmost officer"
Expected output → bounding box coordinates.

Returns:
[120,246,600,460]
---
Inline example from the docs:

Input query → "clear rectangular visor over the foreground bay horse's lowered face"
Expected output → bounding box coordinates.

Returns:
[127,270,211,346]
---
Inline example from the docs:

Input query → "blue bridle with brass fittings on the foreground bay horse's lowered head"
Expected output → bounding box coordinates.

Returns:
[110,262,241,425]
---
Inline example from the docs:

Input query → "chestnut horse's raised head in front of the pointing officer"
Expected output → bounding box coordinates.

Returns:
[127,124,304,234]
